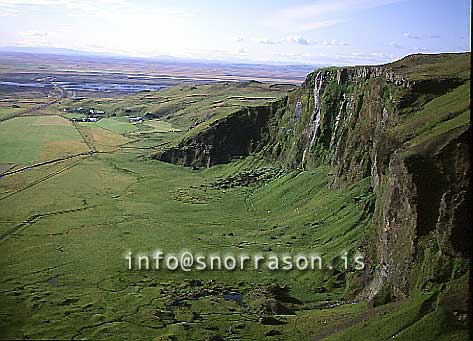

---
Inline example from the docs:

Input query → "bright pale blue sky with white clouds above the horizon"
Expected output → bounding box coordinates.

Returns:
[0,0,471,65]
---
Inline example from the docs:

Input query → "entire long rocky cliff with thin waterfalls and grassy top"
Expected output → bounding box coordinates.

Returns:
[156,54,471,298]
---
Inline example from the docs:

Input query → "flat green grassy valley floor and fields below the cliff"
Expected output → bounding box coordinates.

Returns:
[0,91,464,340]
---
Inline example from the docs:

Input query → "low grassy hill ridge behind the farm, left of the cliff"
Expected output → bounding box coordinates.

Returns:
[57,81,295,129]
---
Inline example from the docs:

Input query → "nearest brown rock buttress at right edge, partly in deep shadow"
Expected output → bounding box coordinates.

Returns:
[366,130,471,297]
